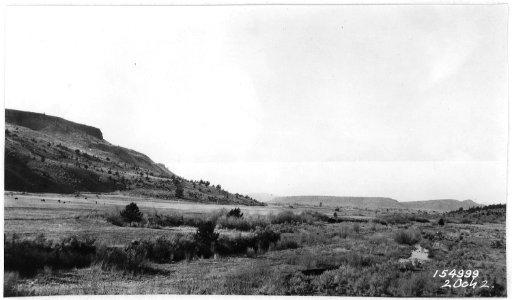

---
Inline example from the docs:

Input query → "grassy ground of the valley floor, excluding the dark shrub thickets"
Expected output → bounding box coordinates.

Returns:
[4,193,506,297]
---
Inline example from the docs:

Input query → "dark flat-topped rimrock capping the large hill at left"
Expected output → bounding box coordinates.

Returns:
[5,109,103,140]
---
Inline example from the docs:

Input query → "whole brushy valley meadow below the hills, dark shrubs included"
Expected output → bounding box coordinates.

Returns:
[4,193,506,296]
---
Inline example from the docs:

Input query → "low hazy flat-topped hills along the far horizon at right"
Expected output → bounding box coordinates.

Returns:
[270,196,480,211]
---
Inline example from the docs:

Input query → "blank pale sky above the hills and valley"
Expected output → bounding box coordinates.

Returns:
[5,5,508,203]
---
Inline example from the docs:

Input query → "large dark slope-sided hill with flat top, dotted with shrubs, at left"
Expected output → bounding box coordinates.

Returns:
[5,109,261,205]
